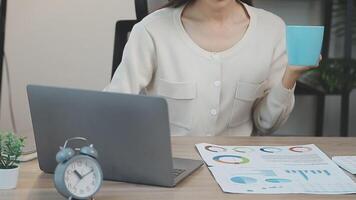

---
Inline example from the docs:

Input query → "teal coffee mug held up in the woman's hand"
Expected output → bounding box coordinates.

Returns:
[287,26,324,66]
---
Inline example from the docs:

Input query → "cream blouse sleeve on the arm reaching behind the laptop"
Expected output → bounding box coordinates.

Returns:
[104,23,156,94]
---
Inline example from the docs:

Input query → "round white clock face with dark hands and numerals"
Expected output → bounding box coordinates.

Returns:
[64,157,102,198]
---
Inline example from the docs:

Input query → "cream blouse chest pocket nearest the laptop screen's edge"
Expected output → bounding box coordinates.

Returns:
[158,79,197,135]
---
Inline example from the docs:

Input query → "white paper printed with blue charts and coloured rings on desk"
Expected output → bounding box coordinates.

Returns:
[196,144,356,194]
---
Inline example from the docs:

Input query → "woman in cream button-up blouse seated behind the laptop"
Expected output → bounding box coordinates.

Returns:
[105,0,318,136]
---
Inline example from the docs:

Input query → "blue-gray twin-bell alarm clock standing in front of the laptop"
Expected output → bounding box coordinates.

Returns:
[54,137,103,200]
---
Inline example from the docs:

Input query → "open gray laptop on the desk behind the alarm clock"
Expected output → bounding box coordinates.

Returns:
[27,85,203,187]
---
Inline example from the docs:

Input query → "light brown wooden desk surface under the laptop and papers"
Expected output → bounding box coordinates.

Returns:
[0,137,356,200]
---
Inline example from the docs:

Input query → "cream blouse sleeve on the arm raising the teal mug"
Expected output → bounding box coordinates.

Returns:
[253,23,295,135]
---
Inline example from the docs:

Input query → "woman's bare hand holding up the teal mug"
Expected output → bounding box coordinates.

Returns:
[282,56,322,89]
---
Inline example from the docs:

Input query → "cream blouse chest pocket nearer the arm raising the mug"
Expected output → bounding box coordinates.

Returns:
[228,81,265,127]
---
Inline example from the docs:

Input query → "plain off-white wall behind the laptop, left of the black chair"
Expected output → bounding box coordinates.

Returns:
[0,0,135,152]
